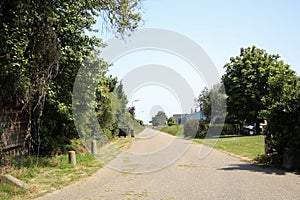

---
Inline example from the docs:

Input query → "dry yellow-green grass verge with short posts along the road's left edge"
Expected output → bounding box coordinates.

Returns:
[0,127,143,200]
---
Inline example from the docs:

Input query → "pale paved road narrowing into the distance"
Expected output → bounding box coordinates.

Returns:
[39,129,300,200]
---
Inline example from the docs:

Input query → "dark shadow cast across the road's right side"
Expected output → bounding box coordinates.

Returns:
[218,164,286,175]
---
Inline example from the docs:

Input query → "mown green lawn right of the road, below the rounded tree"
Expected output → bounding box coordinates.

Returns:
[193,135,264,160]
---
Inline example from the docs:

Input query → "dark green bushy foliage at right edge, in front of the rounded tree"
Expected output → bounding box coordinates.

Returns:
[261,69,300,154]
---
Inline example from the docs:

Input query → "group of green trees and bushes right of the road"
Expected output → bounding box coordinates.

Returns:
[198,46,300,154]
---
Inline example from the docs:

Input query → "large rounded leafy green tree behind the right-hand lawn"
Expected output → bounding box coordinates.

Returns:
[222,46,290,132]
